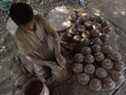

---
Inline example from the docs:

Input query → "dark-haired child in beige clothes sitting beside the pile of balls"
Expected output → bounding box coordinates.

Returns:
[9,3,66,95]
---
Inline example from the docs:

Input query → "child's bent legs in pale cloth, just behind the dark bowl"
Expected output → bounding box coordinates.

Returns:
[21,52,67,81]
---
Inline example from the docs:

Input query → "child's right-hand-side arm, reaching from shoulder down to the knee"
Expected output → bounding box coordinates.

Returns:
[38,15,66,68]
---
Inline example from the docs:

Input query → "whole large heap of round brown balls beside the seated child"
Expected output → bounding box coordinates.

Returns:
[61,11,125,91]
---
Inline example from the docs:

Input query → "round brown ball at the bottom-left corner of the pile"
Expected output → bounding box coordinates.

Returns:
[77,73,90,85]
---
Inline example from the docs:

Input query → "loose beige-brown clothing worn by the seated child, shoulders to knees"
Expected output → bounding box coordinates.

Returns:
[16,15,65,81]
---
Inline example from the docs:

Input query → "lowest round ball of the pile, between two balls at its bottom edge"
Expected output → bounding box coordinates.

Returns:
[89,78,102,91]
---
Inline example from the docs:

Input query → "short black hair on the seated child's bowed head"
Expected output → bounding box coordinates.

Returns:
[9,3,33,25]
